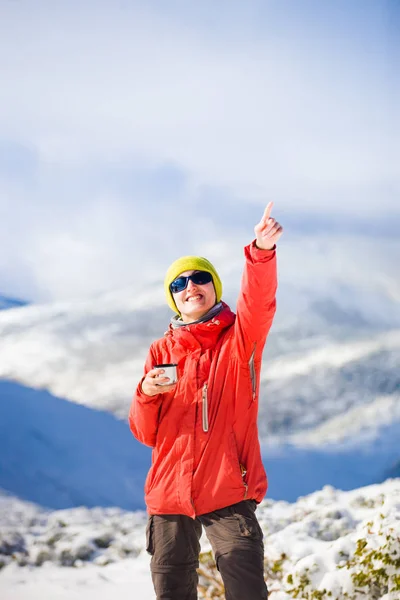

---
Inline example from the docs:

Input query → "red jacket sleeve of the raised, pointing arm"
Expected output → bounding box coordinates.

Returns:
[235,241,277,361]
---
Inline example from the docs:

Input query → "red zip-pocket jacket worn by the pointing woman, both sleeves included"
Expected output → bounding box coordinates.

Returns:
[129,242,277,518]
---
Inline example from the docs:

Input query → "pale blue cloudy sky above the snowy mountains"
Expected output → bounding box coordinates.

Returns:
[0,0,400,301]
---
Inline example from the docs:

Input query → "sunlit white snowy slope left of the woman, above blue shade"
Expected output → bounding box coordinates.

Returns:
[0,284,169,418]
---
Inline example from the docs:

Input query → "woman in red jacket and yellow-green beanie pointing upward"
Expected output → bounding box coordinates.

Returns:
[129,202,282,600]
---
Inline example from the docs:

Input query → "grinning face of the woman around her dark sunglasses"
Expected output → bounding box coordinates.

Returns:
[172,271,216,323]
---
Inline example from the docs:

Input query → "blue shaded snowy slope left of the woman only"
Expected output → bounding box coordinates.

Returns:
[0,382,151,509]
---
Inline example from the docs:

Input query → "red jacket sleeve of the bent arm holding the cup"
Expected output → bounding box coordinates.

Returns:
[128,347,163,448]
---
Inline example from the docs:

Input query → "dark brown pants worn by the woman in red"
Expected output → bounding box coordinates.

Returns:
[147,500,268,600]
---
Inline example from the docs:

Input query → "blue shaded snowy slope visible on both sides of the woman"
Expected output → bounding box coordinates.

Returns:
[0,382,400,510]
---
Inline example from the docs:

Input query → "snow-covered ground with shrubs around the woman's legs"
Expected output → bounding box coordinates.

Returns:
[0,479,400,600]
